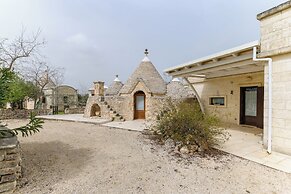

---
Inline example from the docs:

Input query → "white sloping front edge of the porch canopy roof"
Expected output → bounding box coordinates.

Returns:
[164,40,259,73]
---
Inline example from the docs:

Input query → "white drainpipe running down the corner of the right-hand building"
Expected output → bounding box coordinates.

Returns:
[253,47,273,154]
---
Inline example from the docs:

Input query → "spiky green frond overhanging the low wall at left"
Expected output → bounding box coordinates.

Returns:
[0,113,44,139]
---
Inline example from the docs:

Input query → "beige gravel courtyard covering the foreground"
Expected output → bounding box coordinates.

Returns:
[8,120,291,194]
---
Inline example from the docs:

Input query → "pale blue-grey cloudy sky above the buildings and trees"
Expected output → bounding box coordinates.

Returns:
[0,0,285,91]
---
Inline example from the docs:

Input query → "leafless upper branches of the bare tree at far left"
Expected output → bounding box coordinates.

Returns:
[0,29,45,70]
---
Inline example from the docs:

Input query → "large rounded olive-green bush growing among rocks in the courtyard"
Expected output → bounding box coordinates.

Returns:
[152,102,227,151]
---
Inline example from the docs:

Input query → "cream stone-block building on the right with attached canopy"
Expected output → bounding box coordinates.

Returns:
[165,1,291,154]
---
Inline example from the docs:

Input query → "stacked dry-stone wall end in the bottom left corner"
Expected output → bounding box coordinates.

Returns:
[0,137,21,193]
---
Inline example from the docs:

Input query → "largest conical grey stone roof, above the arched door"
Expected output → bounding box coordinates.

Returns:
[120,56,167,94]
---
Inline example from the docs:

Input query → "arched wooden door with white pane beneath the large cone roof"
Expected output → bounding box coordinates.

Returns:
[134,91,146,119]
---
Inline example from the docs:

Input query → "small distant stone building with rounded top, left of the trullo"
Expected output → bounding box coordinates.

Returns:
[42,85,78,111]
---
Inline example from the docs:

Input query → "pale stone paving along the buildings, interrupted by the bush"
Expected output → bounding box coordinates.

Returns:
[39,114,291,173]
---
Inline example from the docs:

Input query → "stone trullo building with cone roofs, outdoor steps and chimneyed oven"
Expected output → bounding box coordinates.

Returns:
[84,51,195,121]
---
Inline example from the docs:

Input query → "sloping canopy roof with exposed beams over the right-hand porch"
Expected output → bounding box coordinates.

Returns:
[165,41,264,79]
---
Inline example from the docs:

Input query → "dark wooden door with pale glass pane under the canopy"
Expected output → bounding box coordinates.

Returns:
[240,86,264,128]
